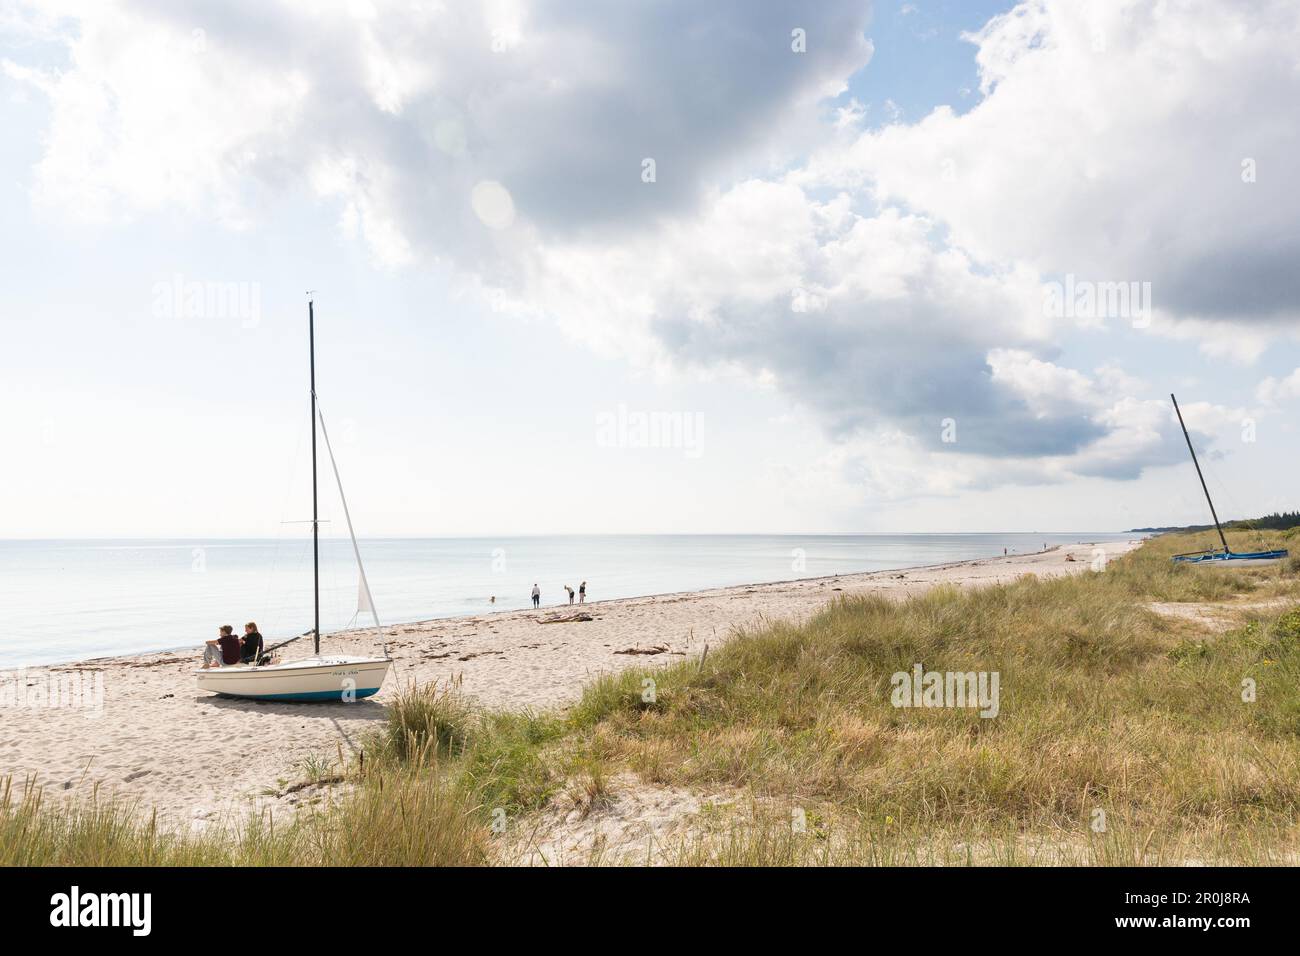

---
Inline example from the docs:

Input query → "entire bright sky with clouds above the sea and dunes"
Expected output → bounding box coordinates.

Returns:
[0,3,1300,537]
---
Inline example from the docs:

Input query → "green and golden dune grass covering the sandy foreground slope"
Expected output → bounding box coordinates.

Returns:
[0,529,1300,865]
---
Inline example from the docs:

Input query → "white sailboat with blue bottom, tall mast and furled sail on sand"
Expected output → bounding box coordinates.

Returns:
[195,299,393,701]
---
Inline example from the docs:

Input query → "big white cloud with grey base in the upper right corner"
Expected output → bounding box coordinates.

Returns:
[811,0,1300,338]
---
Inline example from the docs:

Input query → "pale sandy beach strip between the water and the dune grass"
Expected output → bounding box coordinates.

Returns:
[0,538,1138,826]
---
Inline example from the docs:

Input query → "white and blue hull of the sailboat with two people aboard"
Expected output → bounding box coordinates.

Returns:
[195,657,393,701]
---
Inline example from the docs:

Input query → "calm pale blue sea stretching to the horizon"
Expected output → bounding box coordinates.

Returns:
[0,532,1131,667]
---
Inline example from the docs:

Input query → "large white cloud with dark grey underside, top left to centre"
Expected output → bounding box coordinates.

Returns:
[9,0,871,252]
